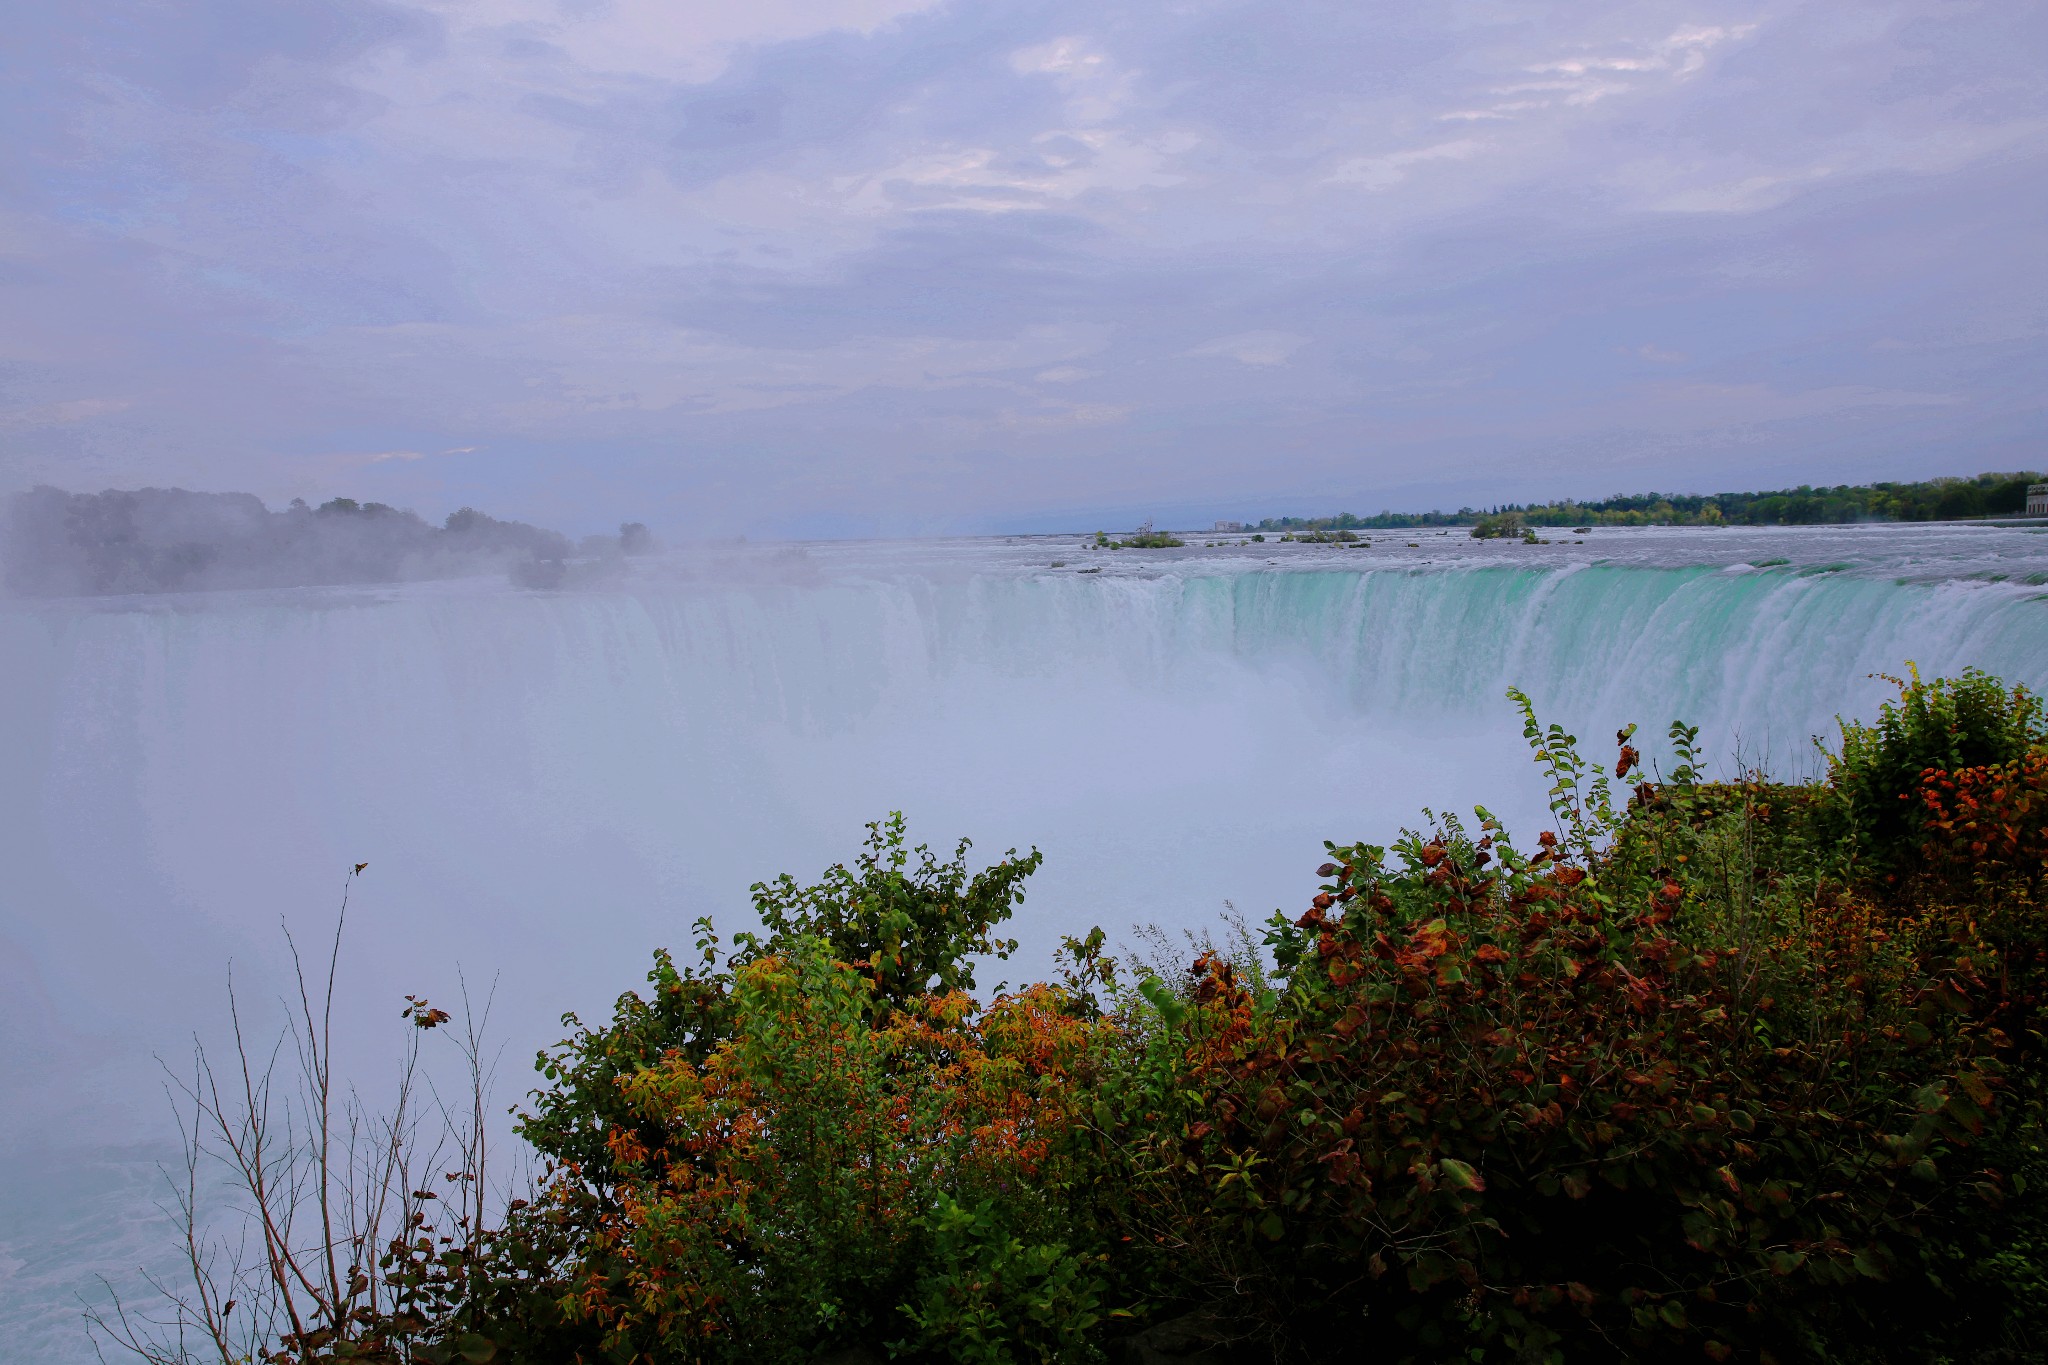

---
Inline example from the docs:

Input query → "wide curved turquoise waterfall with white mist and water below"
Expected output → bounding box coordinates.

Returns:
[0,519,2048,1363]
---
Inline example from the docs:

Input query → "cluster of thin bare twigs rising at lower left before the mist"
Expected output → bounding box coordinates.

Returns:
[86,866,510,1365]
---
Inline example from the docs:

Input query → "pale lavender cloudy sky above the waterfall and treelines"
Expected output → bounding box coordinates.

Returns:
[0,0,2048,534]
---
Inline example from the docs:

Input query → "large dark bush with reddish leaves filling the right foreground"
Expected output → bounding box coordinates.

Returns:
[1151,696,2044,1361]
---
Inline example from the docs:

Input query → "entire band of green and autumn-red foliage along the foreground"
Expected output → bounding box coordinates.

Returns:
[116,673,2048,1365]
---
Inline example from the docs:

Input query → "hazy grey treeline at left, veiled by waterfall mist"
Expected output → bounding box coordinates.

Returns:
[0,487,602,598]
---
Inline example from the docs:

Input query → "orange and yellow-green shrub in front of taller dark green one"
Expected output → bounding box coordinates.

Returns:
[536,939,1100,1361]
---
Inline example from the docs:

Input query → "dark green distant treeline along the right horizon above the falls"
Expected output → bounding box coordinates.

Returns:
[1257,473,2042,530]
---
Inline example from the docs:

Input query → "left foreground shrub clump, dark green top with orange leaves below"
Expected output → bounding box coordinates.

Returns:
[385,817,1120,1363]
